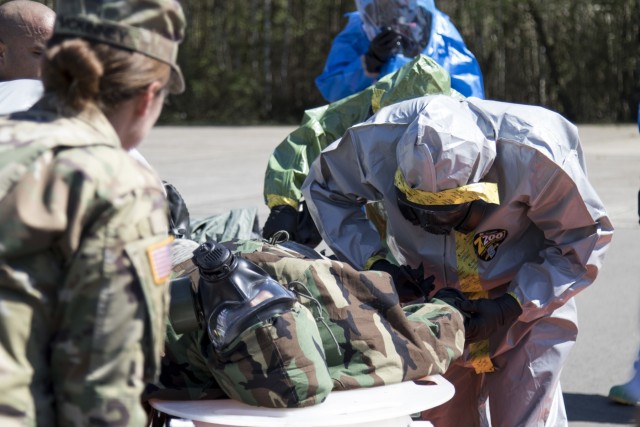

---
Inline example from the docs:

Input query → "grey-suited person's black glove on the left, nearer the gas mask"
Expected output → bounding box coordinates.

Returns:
[370,259,434,302]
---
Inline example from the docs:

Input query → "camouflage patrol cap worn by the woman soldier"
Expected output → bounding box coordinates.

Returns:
[54,0,185,93]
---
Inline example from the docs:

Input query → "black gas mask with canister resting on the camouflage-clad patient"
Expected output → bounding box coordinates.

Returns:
[169,240,296,350]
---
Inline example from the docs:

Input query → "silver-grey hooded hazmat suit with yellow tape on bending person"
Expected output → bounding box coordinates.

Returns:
[302,95,613,426]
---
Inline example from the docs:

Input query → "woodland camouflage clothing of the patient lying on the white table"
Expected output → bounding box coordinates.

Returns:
[159,241,464,407]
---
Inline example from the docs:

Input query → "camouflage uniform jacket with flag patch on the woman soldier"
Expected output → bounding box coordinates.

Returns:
[0,99,170,426]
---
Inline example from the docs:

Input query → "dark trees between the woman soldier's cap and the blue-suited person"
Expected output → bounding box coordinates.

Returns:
[163,0,347,124]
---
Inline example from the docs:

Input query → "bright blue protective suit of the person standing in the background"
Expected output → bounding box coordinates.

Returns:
[315,8,484,102]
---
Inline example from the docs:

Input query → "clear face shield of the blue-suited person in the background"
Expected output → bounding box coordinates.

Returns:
[356,0,432,58]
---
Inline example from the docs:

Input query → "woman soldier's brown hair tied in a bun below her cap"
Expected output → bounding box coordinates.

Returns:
[42,38,171,112]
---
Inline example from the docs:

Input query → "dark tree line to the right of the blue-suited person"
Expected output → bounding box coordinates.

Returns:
[438,0,640,123]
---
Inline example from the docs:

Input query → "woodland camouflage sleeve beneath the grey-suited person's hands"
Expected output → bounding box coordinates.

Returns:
[240,249,464,390]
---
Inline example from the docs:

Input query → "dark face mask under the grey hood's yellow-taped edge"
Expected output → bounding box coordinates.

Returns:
[396,189,488,235]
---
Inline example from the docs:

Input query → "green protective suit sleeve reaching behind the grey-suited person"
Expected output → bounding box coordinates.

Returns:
[264,55,455,208]
